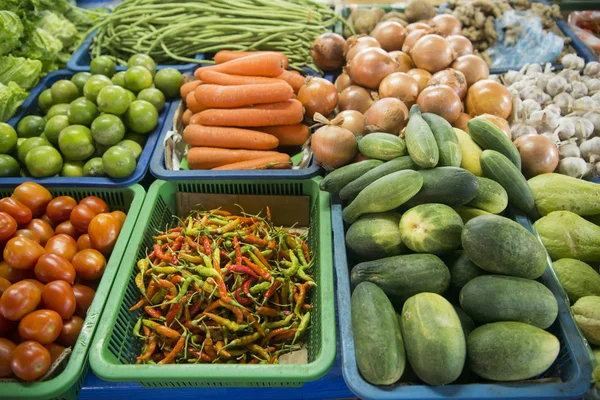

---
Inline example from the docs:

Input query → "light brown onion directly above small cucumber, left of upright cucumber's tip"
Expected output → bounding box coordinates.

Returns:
[365,97,408,135]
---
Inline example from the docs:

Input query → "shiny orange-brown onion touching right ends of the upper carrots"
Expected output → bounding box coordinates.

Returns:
[298,76,338,118]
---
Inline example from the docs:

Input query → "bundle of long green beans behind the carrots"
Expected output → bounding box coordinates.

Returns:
[84,0,342,70]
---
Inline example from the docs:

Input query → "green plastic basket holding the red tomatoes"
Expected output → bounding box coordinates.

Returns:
[0,185,145,400]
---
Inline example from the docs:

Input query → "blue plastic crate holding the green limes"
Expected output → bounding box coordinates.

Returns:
[0,70,172,188]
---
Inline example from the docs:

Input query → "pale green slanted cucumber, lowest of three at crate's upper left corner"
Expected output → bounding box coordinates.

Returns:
[342,170,423,224]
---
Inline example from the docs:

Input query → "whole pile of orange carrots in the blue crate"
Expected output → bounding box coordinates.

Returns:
[181,50,310,170]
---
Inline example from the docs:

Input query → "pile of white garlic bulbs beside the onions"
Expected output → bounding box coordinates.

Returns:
[501,54,600,178]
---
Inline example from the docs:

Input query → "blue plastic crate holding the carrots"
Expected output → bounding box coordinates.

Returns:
[150,103,321,181]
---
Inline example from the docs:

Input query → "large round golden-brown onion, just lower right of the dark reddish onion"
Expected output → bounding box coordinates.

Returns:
[346,47,397,89]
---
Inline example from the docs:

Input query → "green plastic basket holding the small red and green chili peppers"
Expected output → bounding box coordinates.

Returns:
[90,178,336,387]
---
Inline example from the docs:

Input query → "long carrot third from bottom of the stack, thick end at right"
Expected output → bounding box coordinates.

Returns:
[197,100,303,127]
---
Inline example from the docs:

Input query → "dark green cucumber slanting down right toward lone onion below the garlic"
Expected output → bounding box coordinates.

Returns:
[467,117,521,171]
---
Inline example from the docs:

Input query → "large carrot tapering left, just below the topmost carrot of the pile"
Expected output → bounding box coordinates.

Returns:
[194,52,283,79]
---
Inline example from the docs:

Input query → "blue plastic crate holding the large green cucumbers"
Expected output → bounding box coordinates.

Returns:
[331,196,592,400]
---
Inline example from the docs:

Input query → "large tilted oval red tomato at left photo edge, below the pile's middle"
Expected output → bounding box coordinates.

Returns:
[0,281,42,321]
